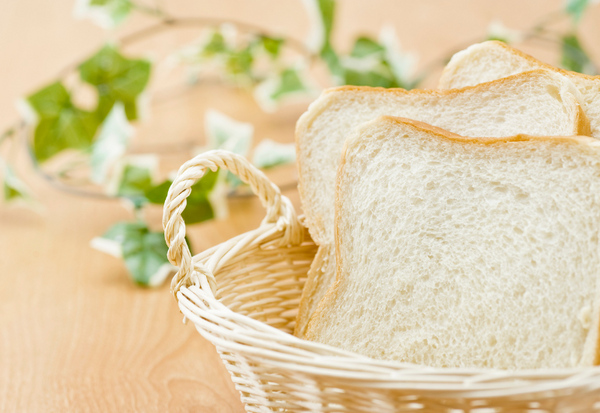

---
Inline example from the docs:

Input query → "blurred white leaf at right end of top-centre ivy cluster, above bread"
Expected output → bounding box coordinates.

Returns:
[379,25,417,88]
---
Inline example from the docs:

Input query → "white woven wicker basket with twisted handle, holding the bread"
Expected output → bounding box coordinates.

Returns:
[163,151,600,413]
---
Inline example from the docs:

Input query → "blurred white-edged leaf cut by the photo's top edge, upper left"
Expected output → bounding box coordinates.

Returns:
[73,0,133,29]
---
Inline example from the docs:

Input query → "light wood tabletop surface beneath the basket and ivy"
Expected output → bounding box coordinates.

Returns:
[0,0,600,412]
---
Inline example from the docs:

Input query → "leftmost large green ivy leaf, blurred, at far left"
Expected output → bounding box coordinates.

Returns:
[27,82,99,162]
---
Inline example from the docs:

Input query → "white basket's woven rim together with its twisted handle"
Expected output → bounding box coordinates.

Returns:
[163,150,600,400]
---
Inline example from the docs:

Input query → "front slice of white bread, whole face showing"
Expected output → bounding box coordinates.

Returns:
[307,117,600,369]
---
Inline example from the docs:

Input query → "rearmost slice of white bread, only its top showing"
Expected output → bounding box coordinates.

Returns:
[439,40,600,138]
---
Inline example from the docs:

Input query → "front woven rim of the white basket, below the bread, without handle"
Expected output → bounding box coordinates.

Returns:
[177,285,600,398]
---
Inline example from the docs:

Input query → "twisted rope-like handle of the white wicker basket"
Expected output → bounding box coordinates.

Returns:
[163,150,303,296]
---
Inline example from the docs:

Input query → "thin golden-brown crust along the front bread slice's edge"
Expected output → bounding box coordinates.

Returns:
[305,116,600,348]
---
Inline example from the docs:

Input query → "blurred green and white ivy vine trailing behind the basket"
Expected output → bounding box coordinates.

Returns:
[0,0,598,286]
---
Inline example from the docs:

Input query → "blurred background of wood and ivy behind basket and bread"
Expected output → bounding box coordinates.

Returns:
[0,0,600,412]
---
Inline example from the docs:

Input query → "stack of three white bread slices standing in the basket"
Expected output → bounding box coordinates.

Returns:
[295,41,600,369]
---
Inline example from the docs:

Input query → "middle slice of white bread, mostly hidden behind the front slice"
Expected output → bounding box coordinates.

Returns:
[294,70,589,337]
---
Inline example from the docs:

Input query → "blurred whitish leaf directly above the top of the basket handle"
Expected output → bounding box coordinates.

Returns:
[204,109,254,156]
